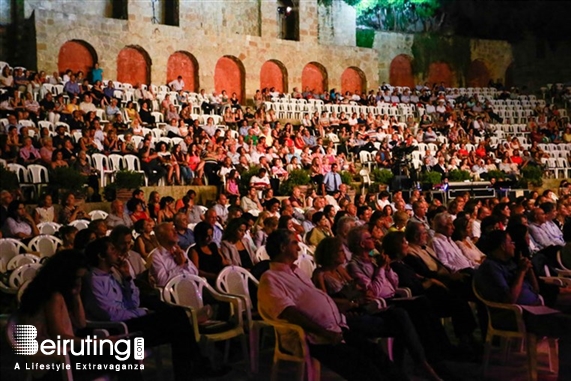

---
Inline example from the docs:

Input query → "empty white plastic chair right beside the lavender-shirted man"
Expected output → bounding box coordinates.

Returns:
[162,275,248,370]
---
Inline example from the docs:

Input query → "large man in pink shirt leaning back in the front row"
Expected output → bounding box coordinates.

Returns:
[258,229,407,381]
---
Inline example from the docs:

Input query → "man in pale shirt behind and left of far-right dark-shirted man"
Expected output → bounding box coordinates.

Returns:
[432,212,473,273]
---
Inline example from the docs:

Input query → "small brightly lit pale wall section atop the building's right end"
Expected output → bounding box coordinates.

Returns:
[317,0,357,46]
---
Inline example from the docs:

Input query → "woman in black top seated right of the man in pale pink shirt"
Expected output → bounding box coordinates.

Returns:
[188,222,229,284]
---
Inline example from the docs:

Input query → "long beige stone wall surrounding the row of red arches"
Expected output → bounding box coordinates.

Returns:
[31,0,378,97]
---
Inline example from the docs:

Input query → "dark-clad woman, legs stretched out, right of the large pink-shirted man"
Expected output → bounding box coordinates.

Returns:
[313,237,440,380]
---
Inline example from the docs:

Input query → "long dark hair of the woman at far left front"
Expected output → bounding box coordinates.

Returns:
[19,250,87,316]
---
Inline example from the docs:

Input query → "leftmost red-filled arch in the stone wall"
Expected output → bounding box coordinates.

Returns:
[58,40,98,77]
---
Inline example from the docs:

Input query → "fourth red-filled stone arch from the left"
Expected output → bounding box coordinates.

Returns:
[214,56,246,103]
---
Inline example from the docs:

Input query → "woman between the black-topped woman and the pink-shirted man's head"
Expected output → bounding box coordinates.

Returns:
[220,218,256,270]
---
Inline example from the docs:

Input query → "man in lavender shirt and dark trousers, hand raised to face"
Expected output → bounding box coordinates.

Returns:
[84,237,201,380]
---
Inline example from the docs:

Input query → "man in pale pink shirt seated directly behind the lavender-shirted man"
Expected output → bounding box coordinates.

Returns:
[150,222,198,287]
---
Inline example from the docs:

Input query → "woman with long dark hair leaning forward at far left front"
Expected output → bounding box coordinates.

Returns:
[18,250,143,380]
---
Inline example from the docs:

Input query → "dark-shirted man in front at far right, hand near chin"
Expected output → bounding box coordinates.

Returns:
[474,230,571,380]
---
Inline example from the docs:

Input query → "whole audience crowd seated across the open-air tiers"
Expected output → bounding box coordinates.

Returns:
[0,63,571,380]
